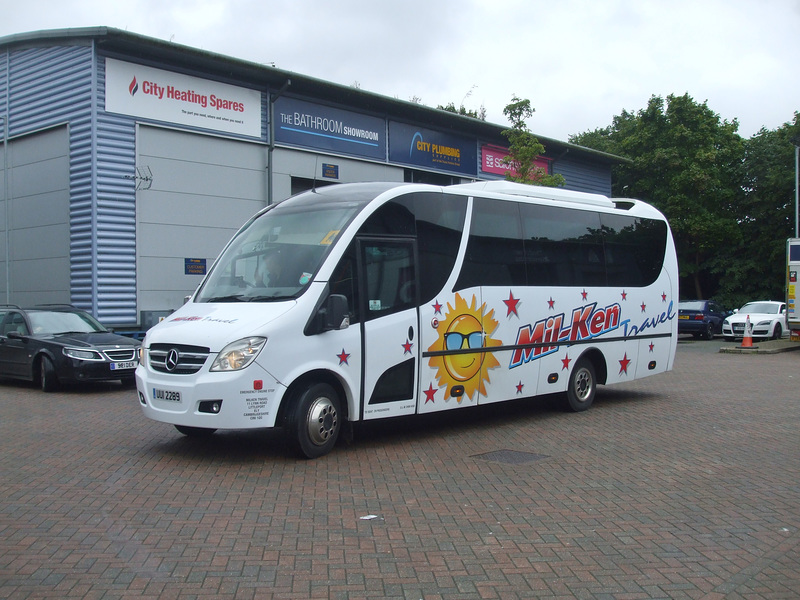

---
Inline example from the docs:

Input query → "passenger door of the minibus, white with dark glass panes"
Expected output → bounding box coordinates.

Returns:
[358,238,419,419]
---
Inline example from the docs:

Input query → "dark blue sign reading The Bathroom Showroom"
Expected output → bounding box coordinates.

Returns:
[273,97,386,160]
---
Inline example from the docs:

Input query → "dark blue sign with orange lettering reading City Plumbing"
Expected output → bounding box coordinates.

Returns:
[389,121,478,176]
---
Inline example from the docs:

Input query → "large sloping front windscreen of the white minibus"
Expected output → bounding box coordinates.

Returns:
[196,200,363,302]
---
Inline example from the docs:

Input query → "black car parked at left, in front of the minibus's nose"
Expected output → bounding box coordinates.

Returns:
[0,304,141,392]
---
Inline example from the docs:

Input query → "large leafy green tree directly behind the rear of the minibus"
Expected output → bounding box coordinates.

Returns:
[570,94,744,298]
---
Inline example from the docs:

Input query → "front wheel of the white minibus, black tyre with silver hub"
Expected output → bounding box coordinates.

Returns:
[284,383,344,458]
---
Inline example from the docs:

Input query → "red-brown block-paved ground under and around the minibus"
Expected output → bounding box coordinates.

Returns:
[0,342,800,599]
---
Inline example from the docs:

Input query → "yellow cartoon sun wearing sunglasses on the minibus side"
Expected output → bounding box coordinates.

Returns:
[428,294,503,402]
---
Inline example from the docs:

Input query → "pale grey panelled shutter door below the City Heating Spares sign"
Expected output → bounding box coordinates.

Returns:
[136,125,267,311]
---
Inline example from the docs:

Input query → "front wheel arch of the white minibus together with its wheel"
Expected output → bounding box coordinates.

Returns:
[276,371,348,458]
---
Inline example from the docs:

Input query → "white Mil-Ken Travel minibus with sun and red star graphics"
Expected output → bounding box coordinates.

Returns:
[136,181,678,458]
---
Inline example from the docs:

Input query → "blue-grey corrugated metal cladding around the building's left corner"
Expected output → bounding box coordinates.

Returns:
[0,45,138,325]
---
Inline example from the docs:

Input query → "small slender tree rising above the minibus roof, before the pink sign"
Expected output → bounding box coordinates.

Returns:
[502,96,564,187]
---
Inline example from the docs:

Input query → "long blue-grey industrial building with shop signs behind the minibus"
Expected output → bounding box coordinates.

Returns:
[0,27,620,329]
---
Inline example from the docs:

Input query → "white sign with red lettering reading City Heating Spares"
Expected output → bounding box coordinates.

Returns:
[106,58,262,138]
